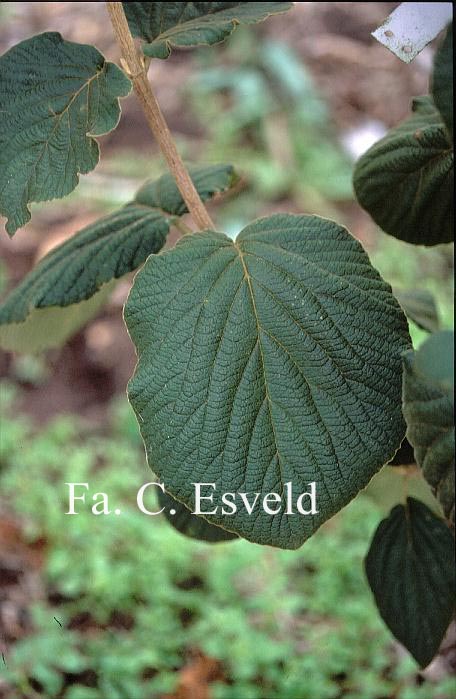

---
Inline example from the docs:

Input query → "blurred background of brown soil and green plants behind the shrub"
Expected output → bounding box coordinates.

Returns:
[0,2,456,699]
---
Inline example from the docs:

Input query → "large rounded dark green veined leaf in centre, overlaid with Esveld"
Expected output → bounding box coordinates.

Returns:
[125,214,410,548]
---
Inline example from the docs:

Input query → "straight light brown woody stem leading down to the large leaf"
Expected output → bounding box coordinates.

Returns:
[106,0,214,229]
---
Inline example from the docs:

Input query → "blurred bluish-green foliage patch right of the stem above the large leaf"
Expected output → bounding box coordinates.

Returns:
[186,30,352,227]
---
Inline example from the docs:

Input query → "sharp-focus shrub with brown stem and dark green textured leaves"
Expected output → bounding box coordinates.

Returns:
[0,3,454,688]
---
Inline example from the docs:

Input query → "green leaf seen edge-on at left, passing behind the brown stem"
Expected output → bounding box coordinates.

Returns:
[0,165,236,352]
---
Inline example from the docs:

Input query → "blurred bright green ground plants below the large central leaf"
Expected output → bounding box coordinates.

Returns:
[0,384,456,699]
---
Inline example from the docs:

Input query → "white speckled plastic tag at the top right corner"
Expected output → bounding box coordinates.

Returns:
[372,2,453,63]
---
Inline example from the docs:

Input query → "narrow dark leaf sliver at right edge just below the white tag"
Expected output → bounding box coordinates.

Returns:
[431,24,453,140]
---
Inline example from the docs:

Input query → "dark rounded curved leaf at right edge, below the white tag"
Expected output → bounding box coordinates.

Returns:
[353,97,454,245]
